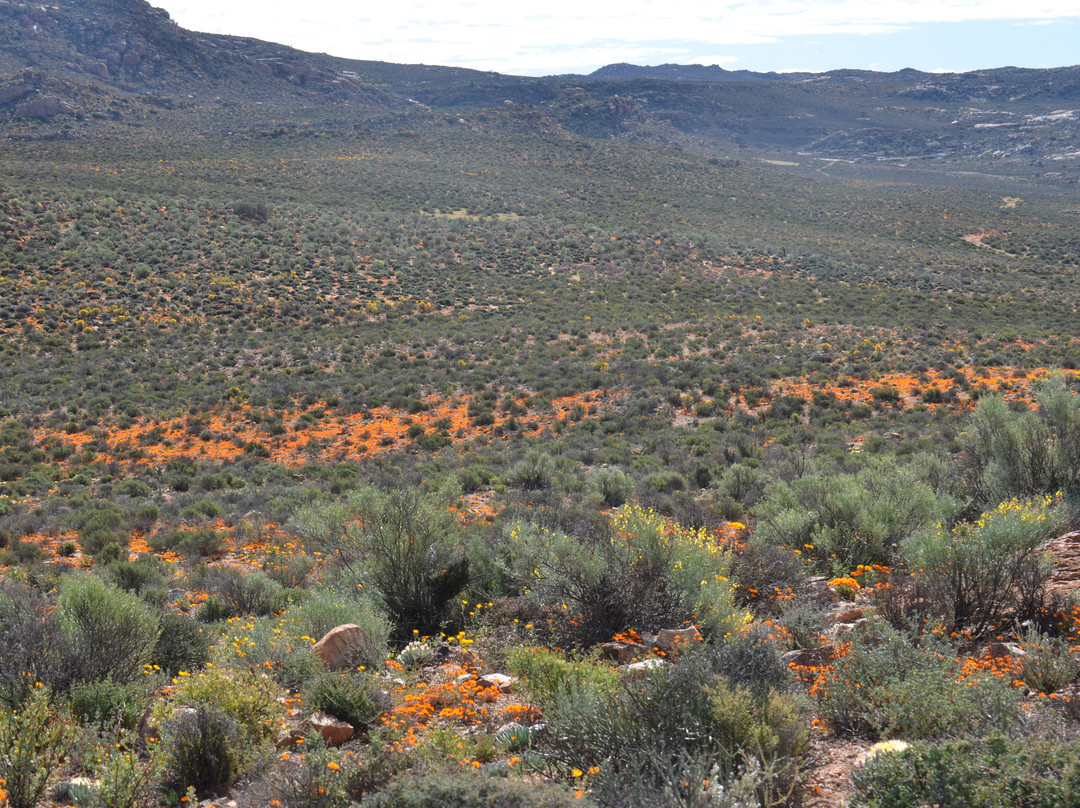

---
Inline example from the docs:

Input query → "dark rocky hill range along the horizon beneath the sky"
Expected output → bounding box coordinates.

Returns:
[0,0,1080,179]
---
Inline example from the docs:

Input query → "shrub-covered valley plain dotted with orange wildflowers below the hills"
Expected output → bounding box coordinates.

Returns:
[0,101,1080,808]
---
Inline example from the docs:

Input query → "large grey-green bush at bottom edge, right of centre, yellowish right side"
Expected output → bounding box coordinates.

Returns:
[540,655,810,805]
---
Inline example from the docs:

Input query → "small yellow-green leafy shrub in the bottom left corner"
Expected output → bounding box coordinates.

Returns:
[0,686,75,808]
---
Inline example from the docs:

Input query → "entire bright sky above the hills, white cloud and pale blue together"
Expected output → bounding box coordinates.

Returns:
[150,0,1080,76]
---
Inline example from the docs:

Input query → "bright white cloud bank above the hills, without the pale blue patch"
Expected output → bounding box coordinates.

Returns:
[151,0,1080,72]
